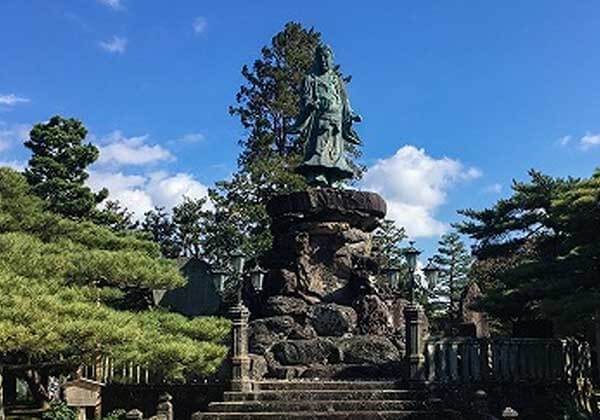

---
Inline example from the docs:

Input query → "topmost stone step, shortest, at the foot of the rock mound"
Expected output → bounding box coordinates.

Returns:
[254,380,406,391]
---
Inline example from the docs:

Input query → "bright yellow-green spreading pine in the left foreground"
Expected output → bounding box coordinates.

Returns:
[0,168,229,402]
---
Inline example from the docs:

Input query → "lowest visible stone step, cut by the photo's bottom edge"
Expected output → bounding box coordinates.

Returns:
[192,410,448,420]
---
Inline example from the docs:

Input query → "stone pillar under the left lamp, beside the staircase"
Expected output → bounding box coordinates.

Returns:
[228,302,252,392]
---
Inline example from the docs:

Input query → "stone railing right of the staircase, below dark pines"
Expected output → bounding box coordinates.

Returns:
[423,338,591,384]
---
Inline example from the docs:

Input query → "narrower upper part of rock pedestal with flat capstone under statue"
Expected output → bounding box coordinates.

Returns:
[264,188,386,305]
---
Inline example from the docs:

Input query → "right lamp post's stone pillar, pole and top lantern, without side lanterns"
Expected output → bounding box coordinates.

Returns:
[404,241,425,381]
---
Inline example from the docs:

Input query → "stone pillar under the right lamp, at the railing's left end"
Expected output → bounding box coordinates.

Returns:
[404,303,425,381]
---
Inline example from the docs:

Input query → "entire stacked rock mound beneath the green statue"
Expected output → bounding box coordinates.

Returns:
[249,188,412,379]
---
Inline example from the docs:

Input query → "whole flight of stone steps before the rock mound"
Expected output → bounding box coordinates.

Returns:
[192,380,449,420]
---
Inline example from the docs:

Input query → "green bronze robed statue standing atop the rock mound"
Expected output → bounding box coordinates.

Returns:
[289,45,361,186]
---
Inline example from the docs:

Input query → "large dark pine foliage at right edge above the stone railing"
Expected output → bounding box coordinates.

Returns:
[459,171,600,334]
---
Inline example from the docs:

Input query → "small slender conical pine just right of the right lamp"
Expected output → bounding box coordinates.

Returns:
[433,232,472,319]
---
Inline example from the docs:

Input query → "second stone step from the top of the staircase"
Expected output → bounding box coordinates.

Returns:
[224,389,428,401]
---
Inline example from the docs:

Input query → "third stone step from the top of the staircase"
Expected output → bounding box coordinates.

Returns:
[208,400,440,413]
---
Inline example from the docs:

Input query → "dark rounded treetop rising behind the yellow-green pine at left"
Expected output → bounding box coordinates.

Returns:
[25,116,108,219]
